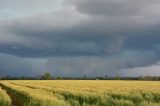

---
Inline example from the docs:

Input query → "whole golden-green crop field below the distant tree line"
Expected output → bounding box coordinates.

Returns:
[0,80,160,106]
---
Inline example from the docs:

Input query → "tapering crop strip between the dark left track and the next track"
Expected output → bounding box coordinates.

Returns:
[1,82,69,106]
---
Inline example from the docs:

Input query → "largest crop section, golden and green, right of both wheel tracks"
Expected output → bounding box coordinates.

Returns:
[1,81,160,106]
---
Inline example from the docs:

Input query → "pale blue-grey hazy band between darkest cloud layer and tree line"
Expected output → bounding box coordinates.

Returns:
[0,50,158,76]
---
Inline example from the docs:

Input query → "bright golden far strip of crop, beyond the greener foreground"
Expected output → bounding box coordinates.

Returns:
[10,80,160,92]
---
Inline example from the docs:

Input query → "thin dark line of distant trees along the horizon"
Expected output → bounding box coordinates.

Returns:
[0,73,160,81]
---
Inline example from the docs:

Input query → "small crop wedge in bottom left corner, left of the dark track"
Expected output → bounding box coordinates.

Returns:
[0,87,11,106]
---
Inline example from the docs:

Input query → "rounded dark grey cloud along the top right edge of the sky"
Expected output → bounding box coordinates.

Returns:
[66,0,160,17]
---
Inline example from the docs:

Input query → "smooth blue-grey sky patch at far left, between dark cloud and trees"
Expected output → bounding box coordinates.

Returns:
[0,53,47,76]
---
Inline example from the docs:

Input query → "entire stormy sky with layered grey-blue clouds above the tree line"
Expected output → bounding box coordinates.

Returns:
[0,0,160,76]
